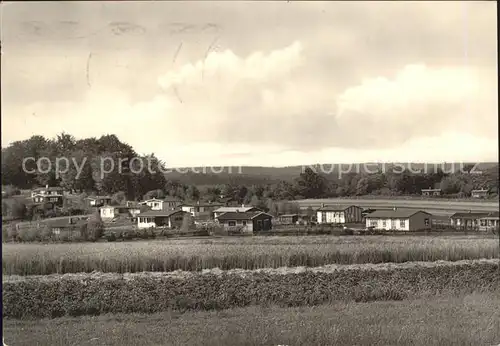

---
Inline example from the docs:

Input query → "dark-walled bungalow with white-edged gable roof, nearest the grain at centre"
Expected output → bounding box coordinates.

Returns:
[216,211,273,232]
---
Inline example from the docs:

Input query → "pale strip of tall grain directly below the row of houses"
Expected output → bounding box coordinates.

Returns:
[2,235,499,275]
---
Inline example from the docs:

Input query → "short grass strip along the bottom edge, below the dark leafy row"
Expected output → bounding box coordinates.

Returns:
[3,293,500,346]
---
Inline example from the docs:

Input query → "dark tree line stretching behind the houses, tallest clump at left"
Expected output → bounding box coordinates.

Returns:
[2,133,498,209]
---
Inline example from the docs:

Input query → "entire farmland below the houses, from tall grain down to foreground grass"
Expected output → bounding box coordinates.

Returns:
[2,235,500,345]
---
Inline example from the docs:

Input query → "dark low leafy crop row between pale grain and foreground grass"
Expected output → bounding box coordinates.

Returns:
[2,263,500,318]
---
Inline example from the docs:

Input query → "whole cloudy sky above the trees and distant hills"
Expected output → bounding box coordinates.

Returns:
[1,1,498,167]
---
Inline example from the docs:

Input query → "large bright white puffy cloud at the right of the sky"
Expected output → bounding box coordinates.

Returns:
[336,65,497,148]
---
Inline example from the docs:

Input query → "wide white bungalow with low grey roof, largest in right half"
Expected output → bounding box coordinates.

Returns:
[366,208,432,231]
